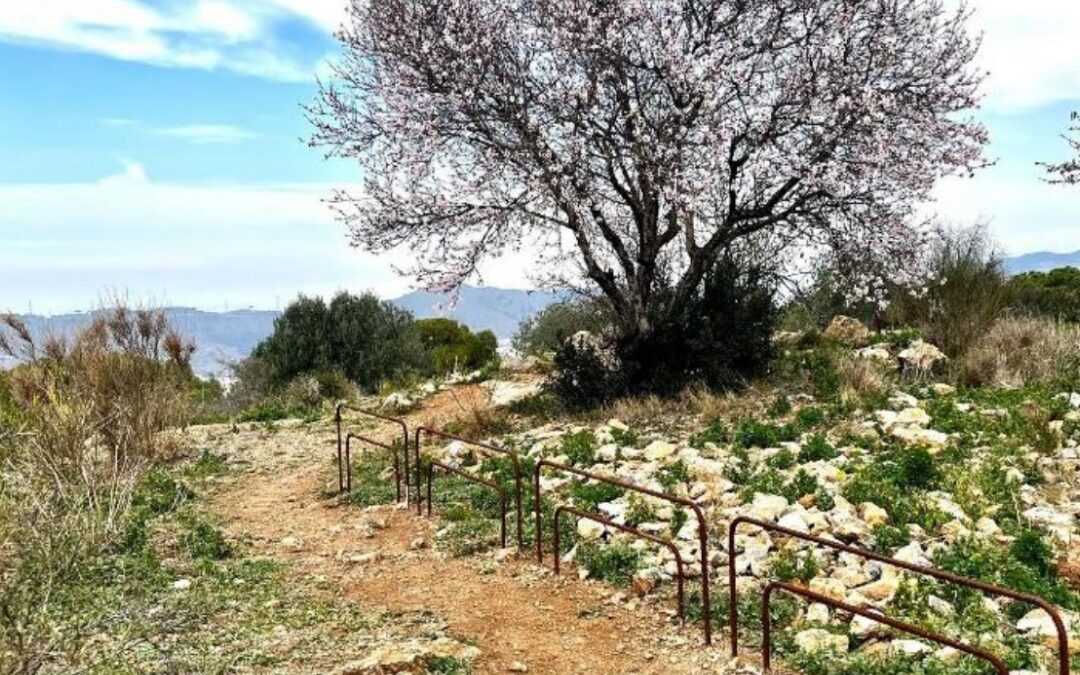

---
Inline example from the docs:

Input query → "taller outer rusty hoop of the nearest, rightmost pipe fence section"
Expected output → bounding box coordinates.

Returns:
[728,516,1069,675]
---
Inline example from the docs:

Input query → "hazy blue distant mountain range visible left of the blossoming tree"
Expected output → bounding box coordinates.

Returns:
[6,286,561,375]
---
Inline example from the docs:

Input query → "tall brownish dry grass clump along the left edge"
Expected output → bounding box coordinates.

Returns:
[0,307,194,673]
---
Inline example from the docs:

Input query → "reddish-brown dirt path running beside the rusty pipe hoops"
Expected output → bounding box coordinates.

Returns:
[196,391,727,674]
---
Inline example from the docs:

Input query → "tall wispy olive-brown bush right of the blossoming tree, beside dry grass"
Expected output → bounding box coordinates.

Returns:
[888,226,1010,357]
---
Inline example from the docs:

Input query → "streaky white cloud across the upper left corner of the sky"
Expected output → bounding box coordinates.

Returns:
[0,0,345,82]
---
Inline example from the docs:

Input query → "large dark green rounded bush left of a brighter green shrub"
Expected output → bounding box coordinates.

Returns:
[253,293,423,391]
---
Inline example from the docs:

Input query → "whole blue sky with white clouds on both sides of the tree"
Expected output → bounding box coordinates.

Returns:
[0,0,1080,312]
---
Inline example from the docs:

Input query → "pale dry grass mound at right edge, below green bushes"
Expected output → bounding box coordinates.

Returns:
[957,316,1080,387]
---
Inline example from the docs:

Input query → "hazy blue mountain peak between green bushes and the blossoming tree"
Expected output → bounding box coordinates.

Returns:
[391,286,564,340]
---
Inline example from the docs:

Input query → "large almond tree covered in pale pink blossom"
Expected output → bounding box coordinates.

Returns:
[308,0,987,349]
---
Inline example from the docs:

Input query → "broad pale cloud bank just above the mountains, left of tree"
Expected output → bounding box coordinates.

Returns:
[0,160,531,312]
